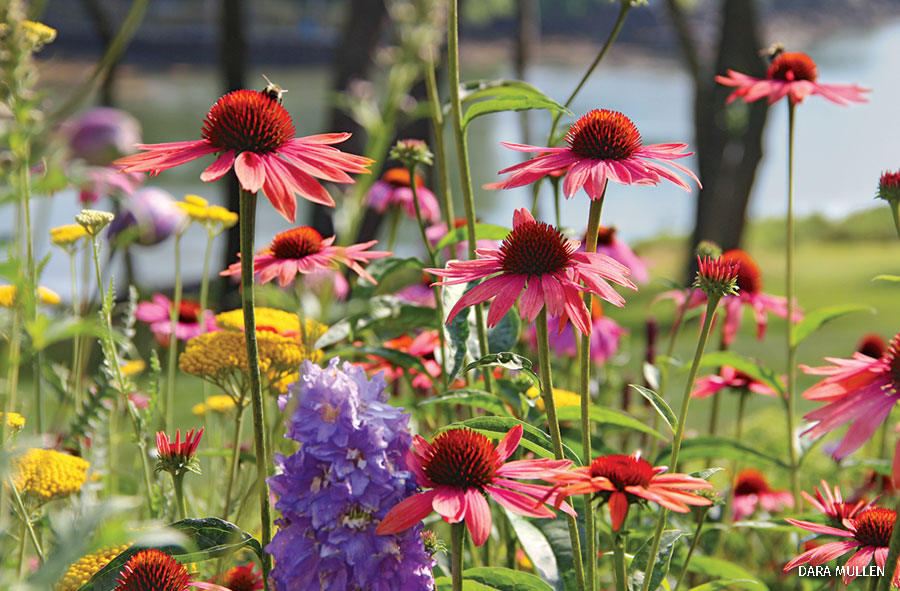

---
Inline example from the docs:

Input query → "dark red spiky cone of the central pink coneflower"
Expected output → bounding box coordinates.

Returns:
[500,222,574,275]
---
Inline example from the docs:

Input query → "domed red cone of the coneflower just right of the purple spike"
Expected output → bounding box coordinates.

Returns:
[422,428,501,490]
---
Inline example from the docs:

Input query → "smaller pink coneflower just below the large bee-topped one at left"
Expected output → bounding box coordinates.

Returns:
[221,226,391,291]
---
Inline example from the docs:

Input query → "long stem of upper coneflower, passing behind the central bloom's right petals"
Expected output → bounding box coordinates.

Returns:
[580,191,608,591]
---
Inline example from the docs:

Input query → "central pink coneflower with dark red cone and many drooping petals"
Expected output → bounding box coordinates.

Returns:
[425,208,637,333]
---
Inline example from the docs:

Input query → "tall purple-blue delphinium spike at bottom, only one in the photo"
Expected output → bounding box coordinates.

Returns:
[266,359,434,591]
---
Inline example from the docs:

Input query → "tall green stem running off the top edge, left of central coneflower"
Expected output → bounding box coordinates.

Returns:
[447,0,494,393]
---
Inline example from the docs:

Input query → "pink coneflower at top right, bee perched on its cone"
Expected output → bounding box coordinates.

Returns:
[716,53,869,105]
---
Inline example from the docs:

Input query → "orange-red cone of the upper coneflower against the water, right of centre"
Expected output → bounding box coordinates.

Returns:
[566,109,642,160]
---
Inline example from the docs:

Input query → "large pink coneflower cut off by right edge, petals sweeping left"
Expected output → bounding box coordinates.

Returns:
[800,334,900,459]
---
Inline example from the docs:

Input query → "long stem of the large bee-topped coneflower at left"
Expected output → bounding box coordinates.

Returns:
[240,189,272,589]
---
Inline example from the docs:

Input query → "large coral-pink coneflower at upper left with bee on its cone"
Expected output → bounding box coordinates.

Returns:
[115,90,372,222]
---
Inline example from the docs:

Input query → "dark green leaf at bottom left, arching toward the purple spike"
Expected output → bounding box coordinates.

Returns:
[78,517,262,591]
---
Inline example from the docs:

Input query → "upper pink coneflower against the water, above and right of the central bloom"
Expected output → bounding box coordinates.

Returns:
[498,109,700,199]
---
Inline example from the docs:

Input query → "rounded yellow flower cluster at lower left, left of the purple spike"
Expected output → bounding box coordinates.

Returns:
[12,448,90,501]
